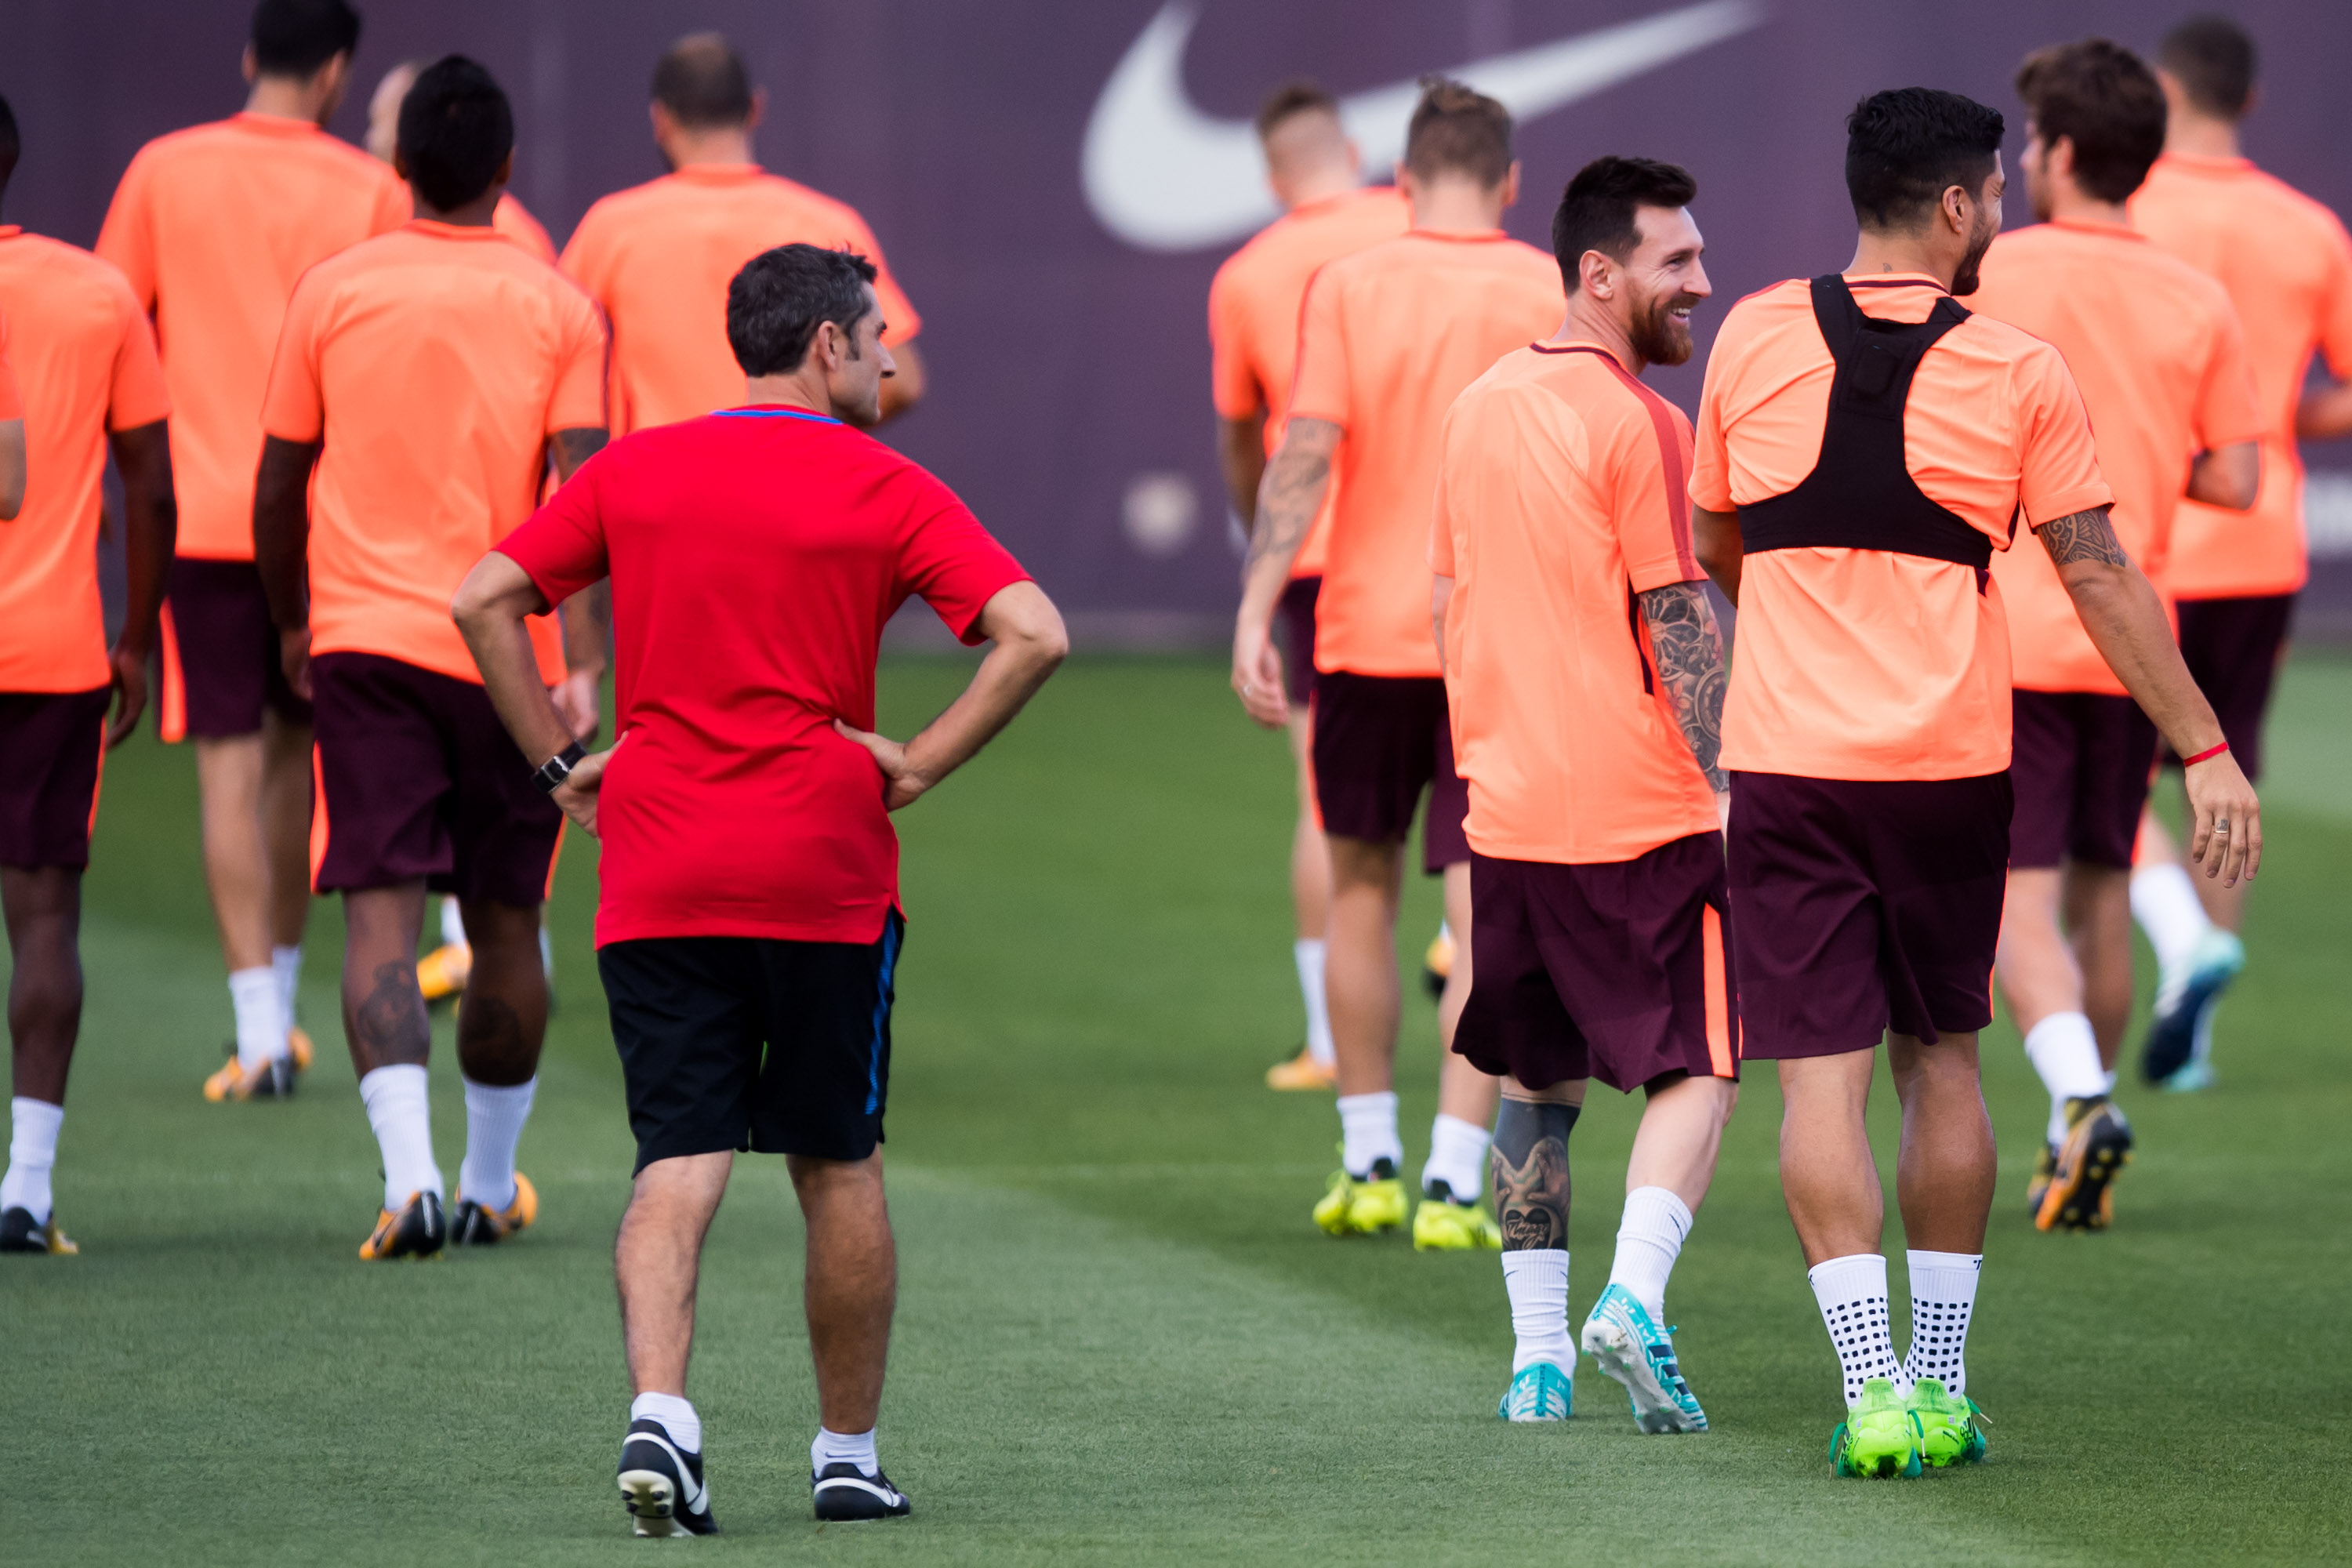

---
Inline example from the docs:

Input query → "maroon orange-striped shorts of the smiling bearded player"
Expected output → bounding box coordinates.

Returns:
[1454,832,1740,1093]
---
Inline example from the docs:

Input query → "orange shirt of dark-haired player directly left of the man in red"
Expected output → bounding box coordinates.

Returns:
[261,219,604,684]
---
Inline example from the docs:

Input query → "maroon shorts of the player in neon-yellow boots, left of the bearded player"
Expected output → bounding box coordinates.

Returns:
[1315,670,1470,877]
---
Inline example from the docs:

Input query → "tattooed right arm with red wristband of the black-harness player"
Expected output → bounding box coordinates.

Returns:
[2039,506,2263,886]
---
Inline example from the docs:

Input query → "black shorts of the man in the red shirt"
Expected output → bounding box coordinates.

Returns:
[595,909,906,1171]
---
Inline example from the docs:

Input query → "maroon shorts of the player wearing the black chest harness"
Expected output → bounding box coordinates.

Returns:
[1731,774,2011,1060]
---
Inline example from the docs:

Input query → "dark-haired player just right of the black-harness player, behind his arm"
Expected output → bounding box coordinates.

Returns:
[1969,38,2263,1229]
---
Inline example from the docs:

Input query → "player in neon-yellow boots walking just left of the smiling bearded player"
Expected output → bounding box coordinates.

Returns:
[1232,78,1564,1250]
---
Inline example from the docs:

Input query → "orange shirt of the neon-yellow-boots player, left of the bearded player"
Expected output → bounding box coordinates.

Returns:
[1289,228,1569,677]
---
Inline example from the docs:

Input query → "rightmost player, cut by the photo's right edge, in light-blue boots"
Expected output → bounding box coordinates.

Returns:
[2131,16,2352,1088]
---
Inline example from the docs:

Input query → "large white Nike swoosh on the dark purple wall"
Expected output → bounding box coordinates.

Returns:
[1080,0,1764,252]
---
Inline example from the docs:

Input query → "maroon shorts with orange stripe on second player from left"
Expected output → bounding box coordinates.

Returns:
[155,555,310,741]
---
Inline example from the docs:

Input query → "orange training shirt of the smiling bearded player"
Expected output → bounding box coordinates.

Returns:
[1430,341,1719,865]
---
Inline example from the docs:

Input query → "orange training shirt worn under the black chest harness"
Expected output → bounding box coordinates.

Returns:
[1691,273,2114,781]
